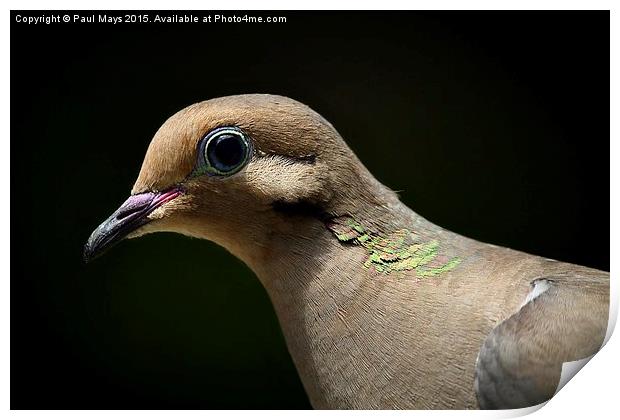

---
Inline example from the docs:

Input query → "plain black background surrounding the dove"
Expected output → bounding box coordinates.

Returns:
[11,11,609,409]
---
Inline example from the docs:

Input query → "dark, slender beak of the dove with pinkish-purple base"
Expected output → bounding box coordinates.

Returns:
[84,187,182,262]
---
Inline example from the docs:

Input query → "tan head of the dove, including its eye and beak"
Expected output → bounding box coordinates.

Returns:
[84,95,395,268]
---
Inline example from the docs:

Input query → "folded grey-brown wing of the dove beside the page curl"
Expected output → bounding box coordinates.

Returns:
[475,273,609,409]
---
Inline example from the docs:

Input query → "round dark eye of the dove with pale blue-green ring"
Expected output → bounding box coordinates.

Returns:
[200,127,251,175]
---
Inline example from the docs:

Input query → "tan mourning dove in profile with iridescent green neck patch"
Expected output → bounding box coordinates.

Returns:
[84,95,609,409]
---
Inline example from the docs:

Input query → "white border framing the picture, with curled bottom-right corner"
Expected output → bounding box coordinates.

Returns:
[0,0,620,420]
